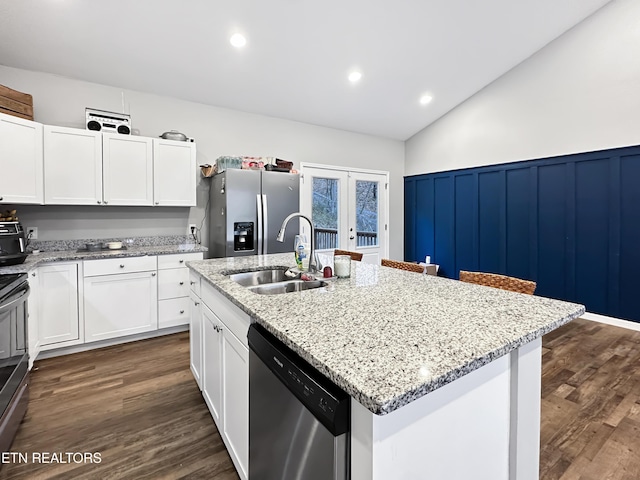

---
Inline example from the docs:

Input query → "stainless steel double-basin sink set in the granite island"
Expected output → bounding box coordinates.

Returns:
[229,268,327,295]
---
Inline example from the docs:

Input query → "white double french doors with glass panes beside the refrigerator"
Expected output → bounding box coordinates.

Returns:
[300,164,389,263]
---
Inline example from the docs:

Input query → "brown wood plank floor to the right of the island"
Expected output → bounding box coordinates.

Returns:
[540,319,640,480]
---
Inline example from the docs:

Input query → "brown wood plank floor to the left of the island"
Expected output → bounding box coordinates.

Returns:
[0,332,238,480]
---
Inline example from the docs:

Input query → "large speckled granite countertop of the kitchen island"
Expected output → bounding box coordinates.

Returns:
[187,253,585,415]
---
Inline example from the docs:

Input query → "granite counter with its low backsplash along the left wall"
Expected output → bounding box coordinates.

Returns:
[0,235,207,274]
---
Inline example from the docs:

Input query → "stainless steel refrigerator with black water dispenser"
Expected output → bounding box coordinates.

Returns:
[209,169,300,258]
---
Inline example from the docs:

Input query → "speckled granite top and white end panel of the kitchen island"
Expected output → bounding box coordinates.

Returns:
[188,254,584,480]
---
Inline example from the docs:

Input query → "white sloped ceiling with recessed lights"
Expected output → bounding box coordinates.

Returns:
[0,0,610,140]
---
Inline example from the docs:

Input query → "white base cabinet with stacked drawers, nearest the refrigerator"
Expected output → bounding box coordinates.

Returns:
[158,253,203,328]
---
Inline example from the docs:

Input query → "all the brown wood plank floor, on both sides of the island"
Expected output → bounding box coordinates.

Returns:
[0,319,640,480]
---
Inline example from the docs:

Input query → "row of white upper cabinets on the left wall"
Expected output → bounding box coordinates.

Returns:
[37,125,192,207]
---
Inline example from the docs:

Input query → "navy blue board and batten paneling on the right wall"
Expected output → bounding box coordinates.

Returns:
[404,147,640,322]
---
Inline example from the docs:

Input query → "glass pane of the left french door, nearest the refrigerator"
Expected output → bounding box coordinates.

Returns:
[311,177,339,250]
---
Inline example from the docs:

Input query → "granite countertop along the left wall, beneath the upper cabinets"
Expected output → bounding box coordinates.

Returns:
[0,243,207,274]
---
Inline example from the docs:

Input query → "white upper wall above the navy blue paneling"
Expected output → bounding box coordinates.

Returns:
[405,0,640,175]
